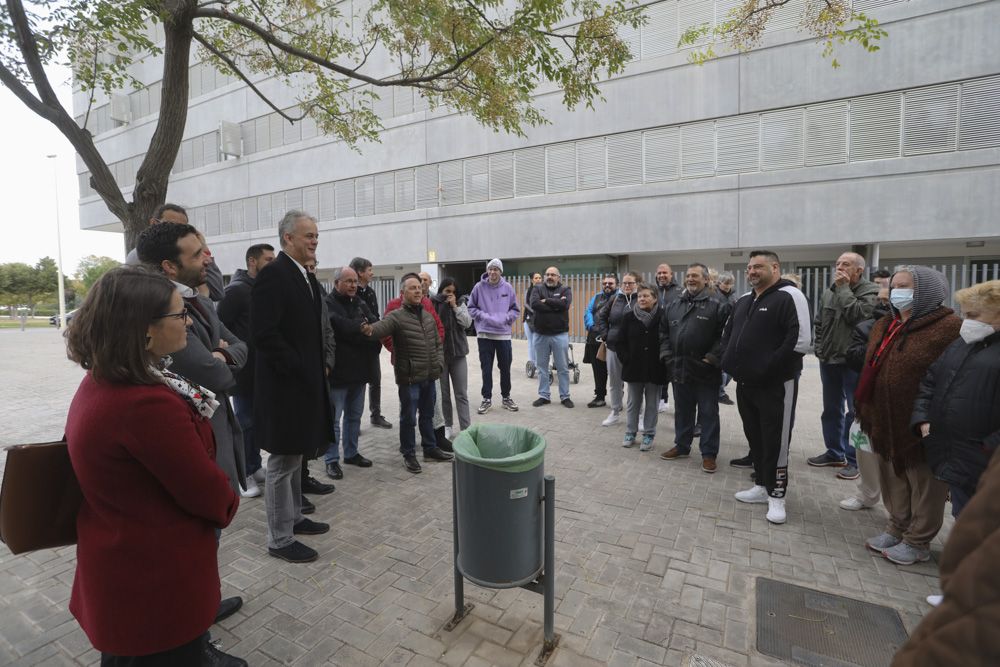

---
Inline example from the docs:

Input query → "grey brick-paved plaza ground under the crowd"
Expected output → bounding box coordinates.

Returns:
[0,330,952,667]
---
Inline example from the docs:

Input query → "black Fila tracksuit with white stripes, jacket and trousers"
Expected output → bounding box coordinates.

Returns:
[722,280,812,498]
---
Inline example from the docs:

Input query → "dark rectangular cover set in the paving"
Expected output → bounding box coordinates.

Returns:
[757,577,907,667]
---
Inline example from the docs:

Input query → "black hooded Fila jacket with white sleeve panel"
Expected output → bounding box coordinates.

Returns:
[722,279,812,386]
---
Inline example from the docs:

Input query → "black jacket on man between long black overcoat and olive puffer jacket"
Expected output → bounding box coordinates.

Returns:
[326,290,382,387]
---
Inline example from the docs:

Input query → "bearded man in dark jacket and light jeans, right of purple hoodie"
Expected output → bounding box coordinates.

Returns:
[531,266,573,408]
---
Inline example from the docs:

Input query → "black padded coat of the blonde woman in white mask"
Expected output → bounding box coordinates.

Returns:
[910,332,1000,494]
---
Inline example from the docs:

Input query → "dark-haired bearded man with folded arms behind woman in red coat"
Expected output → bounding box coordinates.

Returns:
[136,223,247,622]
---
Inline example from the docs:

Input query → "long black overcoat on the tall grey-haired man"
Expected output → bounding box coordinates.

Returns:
[250,252,339,458]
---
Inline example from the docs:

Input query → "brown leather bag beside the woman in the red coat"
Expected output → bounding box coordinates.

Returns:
[0,438,83,554]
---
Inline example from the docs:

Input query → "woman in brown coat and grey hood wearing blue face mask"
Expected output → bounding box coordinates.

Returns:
[854,266,962,565]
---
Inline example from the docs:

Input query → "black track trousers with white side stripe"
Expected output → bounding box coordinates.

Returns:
[736,376,799,498]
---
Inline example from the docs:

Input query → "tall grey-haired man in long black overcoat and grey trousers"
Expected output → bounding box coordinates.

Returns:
[250,210,333,563]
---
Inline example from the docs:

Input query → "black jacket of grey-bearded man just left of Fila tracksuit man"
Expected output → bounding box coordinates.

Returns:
[660,289,730,386]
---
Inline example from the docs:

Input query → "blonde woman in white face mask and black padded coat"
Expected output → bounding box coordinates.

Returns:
[912,280,1000,518]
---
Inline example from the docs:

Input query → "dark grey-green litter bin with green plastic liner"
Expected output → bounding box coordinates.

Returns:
[453,424,545,588]
